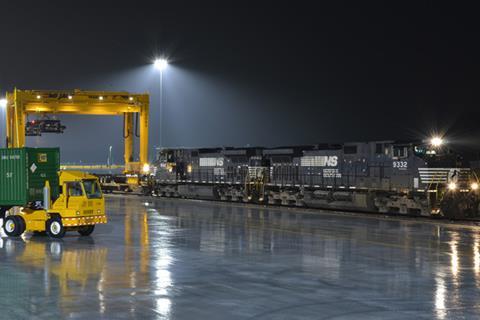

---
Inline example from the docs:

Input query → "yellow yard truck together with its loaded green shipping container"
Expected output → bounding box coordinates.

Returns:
[0,148,107,238]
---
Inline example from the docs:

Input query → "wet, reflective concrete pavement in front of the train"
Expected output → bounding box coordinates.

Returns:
[0,196,480,319]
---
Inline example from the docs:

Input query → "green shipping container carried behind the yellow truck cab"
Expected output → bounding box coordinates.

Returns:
[0,148,60,207]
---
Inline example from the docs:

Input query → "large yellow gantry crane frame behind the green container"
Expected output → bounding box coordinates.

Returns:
[6,89,149,174]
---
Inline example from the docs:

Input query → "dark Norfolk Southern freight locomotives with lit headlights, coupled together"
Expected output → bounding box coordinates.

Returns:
[136,138,480,219]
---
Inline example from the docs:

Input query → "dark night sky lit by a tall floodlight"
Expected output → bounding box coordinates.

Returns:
[0,1,480,162]
